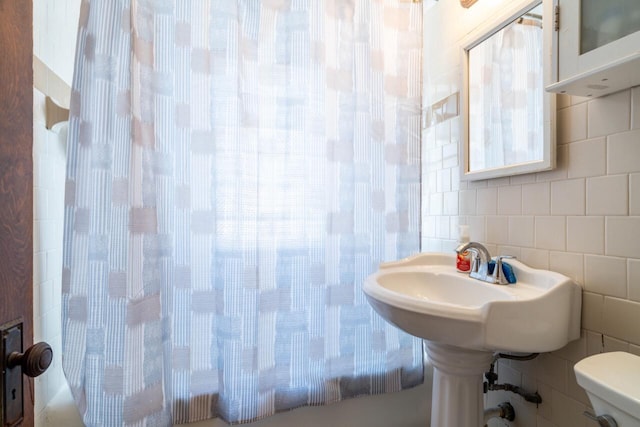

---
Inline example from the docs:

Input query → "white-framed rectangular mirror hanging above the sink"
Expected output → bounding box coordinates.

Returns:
[461,0,556,180]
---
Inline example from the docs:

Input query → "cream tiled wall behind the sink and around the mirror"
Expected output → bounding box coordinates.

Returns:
[422,0,640,427]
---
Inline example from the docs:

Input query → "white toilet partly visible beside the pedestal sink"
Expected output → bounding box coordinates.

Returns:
[573,351,640,427]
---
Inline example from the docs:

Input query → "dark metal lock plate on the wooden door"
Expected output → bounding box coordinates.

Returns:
[0,320,24,427]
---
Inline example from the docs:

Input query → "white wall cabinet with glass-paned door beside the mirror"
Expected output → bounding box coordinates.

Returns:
[554,0,640,96]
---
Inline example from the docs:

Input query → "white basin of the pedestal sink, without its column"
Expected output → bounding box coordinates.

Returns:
[363,253,581,353]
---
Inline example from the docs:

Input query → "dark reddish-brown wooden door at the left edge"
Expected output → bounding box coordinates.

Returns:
[0,0,34,427]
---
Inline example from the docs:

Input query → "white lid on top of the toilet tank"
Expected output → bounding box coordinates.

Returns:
[573,351,640,419]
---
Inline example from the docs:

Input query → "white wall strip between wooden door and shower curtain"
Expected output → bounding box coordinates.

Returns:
[33,0,80,426]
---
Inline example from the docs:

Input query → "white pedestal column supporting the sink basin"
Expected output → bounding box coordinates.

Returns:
[426,341,493,427]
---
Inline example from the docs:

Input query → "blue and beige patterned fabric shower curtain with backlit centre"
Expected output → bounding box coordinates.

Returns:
[63,0,422,426]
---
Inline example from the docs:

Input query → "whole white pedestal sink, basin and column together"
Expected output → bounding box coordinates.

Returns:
[363,253,581,427]
